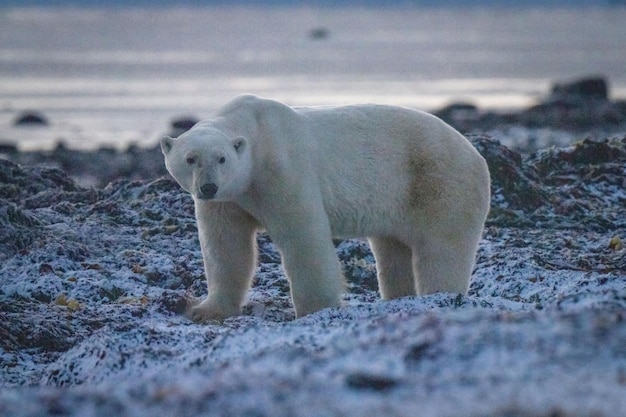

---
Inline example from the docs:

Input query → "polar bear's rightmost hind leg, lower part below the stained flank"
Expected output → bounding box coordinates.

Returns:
[413,235,478,295]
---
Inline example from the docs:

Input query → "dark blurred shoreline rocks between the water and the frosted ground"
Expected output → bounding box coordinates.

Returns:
[0,77,626,188]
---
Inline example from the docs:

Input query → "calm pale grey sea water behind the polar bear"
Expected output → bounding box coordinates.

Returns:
[0,7,626,149]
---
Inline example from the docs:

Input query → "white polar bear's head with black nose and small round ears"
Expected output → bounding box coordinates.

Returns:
[161,125,251,201]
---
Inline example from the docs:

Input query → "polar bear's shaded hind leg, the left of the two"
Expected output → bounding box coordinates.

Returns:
[369,237,416,300]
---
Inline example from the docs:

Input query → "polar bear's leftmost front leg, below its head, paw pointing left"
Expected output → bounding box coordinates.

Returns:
[188,199,258,322]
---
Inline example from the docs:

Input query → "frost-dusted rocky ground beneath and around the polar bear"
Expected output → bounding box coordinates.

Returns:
[0,136,626,417]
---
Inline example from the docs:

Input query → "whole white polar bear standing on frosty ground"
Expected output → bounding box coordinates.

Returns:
[161,95,490,321]
